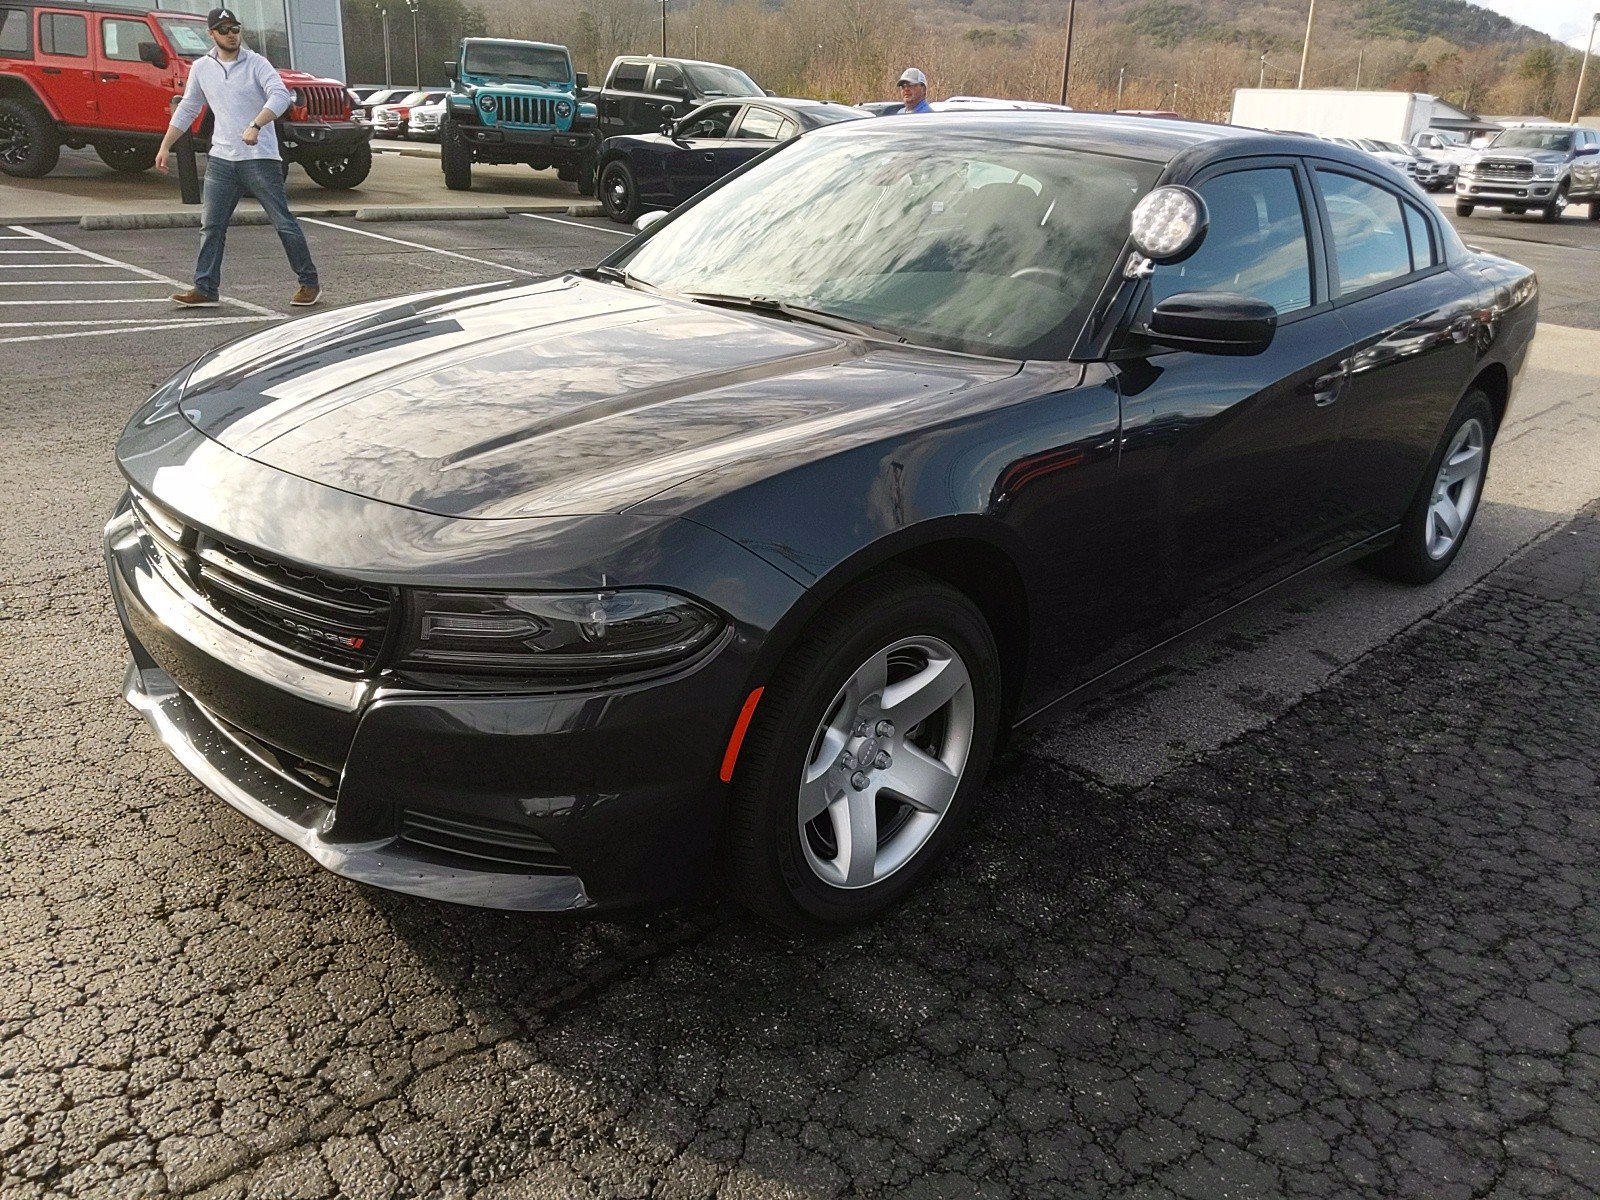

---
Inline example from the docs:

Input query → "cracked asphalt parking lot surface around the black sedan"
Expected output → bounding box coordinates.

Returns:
[0,202,1600,1200]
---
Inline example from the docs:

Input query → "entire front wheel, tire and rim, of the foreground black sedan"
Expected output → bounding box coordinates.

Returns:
[722,571,1000,934]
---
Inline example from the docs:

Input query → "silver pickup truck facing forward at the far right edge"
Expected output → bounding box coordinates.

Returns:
[1456,125,1600,221]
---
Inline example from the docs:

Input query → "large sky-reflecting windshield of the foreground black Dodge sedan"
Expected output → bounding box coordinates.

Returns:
[614,125,1160,358]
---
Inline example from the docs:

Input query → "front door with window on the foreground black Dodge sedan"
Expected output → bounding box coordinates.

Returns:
[1120,158,1349,627]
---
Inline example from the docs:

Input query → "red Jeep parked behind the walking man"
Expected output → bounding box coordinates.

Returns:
[0,0,373,187]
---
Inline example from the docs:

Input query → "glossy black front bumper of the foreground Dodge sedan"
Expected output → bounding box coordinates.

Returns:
[104,501,771,912]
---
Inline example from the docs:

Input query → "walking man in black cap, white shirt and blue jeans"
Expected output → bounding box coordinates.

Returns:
[155,8,322,309]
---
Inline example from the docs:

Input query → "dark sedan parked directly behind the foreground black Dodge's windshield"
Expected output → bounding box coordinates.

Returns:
[598,96,872,221]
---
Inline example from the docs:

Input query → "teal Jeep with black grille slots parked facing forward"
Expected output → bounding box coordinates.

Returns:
[438,37,598,195]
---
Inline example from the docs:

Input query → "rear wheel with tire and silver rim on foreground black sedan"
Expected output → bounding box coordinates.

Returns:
[1362,389,1494,584]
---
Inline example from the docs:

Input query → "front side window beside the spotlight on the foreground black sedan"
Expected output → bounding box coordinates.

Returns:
[1150,166,1312,314]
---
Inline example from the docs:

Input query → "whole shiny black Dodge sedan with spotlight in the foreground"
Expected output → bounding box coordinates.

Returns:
[106,112,1536,930]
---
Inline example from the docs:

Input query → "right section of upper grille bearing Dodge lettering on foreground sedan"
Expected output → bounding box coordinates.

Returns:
[195,534,394,670]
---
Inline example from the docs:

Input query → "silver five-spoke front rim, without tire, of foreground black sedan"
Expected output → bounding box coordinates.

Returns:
[798,637,976,890]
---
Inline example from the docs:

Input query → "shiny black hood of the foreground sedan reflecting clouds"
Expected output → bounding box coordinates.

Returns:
[182,277,1019,518]
